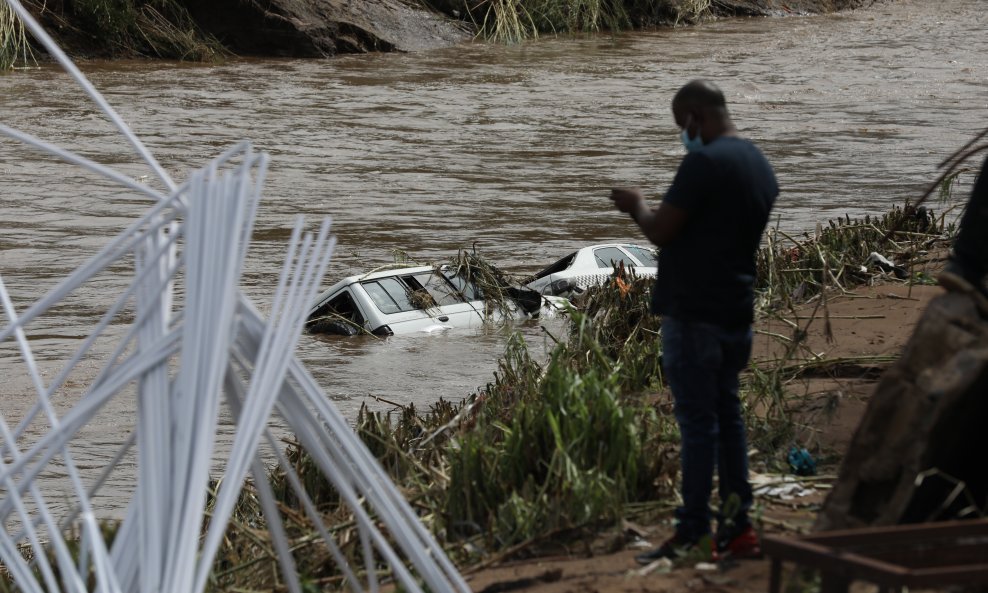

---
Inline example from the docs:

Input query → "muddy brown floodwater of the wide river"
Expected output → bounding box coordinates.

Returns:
[0,0,988,506]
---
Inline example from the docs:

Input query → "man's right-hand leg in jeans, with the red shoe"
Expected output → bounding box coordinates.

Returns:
[716,328,762,558]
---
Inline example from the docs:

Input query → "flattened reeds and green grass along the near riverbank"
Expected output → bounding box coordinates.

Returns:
[201,202,952,589]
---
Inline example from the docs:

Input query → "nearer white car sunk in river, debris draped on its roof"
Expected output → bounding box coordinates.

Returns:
[306,266,564,336]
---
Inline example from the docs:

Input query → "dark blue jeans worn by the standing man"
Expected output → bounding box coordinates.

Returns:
[662,317,752,541]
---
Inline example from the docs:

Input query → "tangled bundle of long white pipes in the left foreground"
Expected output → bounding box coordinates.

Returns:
[0,0,469,593]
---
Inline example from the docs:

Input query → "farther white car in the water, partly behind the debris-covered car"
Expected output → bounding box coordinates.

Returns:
[525,243,659,297]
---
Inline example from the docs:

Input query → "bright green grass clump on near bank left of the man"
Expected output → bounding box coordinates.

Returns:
[443,322,676,549]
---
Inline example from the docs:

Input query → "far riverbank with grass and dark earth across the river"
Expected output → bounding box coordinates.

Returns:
[0,0,808,69]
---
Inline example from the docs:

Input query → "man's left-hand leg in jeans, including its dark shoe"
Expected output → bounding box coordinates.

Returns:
[636,317,721,564]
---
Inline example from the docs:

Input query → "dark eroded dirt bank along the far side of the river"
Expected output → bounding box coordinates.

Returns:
[13,0,891,61]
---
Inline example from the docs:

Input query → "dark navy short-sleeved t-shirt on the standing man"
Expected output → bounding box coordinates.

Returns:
[652,136,779,328]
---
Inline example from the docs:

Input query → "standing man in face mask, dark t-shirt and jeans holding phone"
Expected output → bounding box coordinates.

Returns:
[611,80,779,564]
